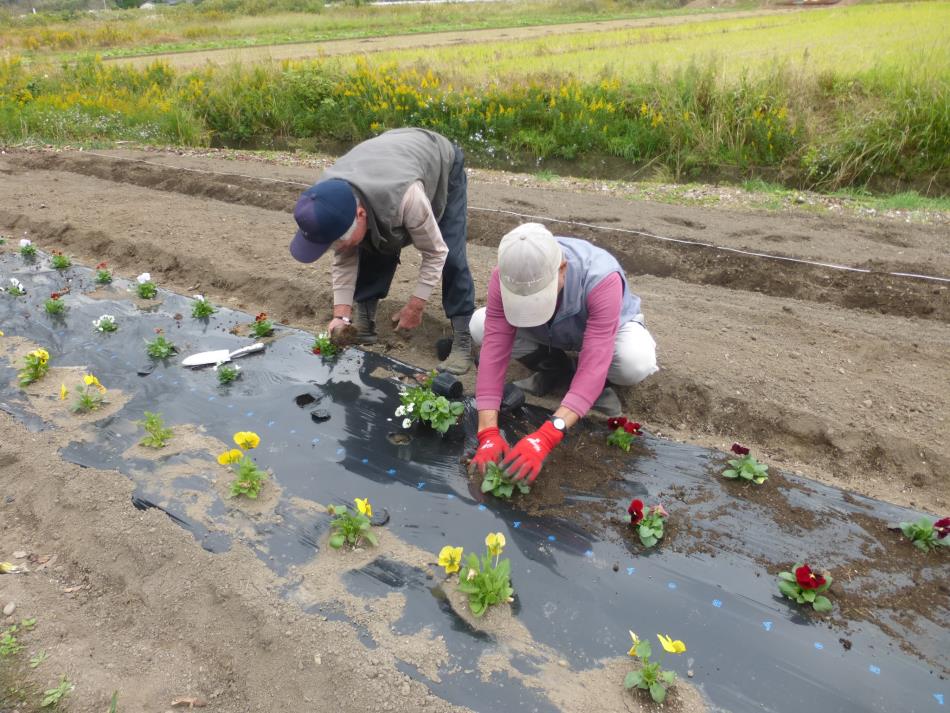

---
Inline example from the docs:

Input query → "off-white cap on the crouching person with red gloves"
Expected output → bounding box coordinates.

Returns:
[498,223,563,327]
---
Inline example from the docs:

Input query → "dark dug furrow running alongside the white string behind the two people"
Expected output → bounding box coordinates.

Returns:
[15,152,950,322]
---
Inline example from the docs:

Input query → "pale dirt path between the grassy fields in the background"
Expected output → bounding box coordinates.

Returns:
[105,8,795,69]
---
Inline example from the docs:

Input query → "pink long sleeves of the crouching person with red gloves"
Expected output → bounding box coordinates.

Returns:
[475,268,623,416]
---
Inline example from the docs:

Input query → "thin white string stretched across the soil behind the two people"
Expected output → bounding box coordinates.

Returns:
[83,151,950,284]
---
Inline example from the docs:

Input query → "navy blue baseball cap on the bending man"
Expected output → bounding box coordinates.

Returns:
[290,178,356,262]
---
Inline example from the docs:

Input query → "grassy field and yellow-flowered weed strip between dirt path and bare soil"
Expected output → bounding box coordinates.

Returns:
[0,2,950,196]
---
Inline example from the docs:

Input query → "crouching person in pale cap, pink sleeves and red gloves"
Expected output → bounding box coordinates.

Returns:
[470,223,657,482]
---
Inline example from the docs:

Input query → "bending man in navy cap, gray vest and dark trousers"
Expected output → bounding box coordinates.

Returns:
[290,129,475,374]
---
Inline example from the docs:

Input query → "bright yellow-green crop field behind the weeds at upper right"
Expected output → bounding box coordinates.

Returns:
[358,2,950,83]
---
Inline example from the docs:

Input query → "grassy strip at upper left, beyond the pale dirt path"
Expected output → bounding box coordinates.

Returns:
[0,0,720,59]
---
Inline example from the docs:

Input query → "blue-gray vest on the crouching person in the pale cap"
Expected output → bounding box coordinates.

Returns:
[527,238,640,352]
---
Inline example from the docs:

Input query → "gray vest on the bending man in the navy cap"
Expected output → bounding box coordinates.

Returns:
[321,129,455,255]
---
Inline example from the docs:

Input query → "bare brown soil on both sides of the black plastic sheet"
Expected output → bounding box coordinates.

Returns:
[0,150,950,713]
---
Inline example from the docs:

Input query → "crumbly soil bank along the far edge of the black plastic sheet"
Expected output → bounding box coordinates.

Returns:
[0,210,950,503]
